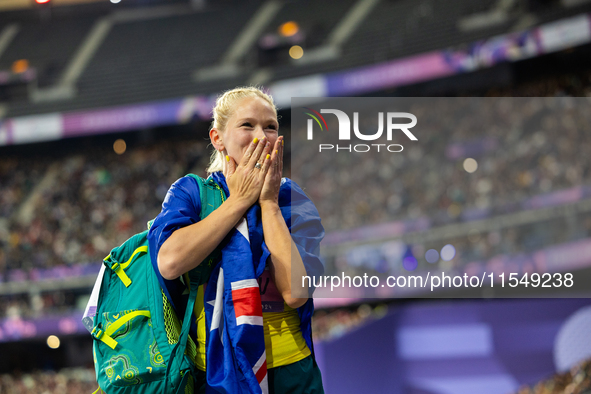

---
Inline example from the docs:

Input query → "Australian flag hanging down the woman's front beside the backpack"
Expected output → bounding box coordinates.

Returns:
[204,178,270,394]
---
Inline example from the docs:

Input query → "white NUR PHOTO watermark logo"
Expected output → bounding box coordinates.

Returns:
[304,107,418,153]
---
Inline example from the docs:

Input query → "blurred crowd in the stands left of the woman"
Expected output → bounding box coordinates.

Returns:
[0,140,213,281]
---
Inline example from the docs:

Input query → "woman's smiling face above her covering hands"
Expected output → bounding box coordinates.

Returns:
[222,97,279,164]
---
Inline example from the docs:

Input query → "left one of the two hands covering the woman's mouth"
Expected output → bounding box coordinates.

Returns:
[225,138,271,211]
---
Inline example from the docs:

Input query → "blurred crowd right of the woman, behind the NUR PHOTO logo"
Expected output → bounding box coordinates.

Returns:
[292,94,591,230]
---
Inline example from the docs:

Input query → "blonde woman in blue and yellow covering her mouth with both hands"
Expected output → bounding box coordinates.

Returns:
[149,87,324,394]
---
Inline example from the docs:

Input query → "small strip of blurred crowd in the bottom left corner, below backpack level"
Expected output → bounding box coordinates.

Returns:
[0,368,98,394]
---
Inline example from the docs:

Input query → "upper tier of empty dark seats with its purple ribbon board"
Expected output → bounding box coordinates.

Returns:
[0,0,591,145]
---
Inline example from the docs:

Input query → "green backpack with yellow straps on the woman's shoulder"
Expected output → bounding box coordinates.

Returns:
[85,174,224,394]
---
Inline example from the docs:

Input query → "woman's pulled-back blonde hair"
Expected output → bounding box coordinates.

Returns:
[207,86,277,174]
